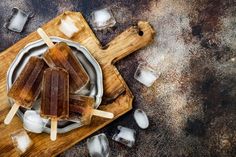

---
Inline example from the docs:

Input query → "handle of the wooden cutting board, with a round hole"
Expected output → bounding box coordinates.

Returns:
[103,21,155,64]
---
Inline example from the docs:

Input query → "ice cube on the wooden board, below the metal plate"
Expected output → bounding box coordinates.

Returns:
[11,129,33,154]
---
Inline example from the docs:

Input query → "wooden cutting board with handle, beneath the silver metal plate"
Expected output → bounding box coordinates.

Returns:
[0,12,154,157]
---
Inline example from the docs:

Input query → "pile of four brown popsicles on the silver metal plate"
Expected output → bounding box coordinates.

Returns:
[4,28,114,140]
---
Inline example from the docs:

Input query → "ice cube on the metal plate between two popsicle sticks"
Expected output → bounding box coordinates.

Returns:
[23,110,48,133]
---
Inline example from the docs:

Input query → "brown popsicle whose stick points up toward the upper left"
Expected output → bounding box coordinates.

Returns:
[37,28,89,93]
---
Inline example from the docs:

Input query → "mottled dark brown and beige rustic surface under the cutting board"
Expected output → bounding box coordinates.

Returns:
[0,0,236,157]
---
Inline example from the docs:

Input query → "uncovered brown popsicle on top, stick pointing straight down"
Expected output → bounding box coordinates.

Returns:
[40,68,69,141]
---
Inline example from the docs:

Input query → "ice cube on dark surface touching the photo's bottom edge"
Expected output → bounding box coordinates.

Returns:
[87,133,110,157]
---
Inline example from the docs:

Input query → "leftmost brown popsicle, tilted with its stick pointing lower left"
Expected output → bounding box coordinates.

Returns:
[4,57,48,124]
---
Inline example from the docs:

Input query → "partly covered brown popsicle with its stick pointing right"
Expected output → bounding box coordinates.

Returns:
[69,94,114,125]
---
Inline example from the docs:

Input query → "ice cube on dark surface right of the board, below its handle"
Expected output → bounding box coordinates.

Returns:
[134,64,160,87]
